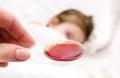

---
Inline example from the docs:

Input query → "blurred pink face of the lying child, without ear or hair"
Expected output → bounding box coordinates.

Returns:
[49,23,85,43]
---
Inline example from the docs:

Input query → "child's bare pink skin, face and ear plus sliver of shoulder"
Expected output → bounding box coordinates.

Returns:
[30,17,86,43]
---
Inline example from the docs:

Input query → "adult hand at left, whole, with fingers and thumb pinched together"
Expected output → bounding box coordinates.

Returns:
[0,8,35,67]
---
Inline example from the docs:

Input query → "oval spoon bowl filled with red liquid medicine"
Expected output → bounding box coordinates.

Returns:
[45,41,83,61]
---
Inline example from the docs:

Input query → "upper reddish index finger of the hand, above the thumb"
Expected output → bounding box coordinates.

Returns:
[0,8,35,47]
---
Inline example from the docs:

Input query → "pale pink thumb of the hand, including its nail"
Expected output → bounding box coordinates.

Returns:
[0,43,30,62]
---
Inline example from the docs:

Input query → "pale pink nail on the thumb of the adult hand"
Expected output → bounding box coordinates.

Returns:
[16,49,30,61]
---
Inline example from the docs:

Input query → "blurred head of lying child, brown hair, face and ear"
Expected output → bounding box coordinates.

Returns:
[30,9,93,43]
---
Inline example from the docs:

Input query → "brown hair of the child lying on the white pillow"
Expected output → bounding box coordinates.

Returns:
[56,9,93,40]
